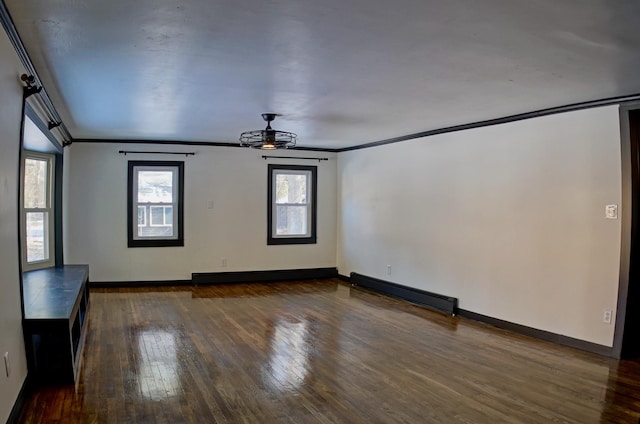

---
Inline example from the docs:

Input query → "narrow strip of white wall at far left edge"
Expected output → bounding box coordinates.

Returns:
[0,31,27,422]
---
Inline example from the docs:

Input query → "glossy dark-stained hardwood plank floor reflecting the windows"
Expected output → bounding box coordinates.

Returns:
[21,280,640,424]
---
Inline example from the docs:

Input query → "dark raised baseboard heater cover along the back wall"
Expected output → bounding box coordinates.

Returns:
[191,268,338,286]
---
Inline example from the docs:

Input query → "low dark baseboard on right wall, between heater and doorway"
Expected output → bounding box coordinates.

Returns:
[458,309,613,357]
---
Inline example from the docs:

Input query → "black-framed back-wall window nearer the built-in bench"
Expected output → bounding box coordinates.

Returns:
[127,161,184,247]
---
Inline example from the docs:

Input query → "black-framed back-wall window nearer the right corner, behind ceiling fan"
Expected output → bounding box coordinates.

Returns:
[267,165,317,244]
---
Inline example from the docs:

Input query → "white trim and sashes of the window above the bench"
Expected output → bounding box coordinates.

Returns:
[20,150,56,271]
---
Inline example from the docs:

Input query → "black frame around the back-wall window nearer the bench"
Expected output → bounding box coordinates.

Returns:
[127,160,184,247]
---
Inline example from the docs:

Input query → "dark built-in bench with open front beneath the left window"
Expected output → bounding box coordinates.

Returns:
[22,265,89,383]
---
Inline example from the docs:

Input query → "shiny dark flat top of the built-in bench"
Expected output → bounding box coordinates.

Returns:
[22,265,89,319]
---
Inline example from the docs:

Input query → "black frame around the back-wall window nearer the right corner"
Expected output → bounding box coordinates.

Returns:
[267,164,318,245]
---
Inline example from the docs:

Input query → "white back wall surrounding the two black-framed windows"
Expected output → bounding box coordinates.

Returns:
[63,143,337,281]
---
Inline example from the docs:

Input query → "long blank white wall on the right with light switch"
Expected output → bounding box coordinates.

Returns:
[338,106,621,346]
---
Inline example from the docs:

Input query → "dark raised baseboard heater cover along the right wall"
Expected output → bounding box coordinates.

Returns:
[350,272,458,315]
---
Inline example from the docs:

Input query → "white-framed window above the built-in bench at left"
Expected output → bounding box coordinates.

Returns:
[21,151,55,271]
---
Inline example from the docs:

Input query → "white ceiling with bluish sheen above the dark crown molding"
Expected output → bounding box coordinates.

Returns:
[4,0,640,149]
